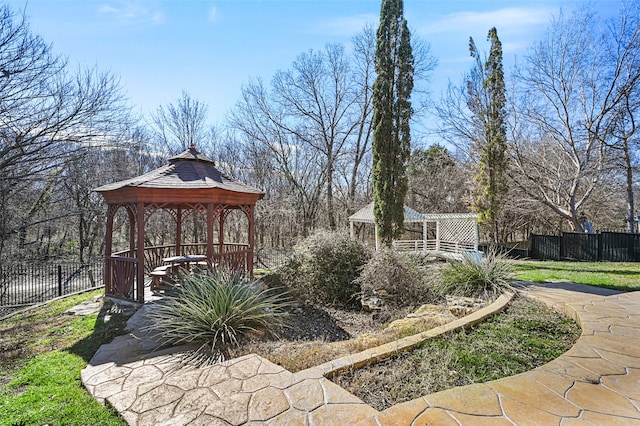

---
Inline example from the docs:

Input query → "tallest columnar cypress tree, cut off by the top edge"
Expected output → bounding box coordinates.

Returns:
[372,0,414,246]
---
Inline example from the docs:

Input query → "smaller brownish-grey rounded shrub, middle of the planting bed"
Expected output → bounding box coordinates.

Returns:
[356,248,432,308]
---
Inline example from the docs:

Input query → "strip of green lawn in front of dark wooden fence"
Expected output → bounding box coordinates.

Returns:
[513,260,640,291]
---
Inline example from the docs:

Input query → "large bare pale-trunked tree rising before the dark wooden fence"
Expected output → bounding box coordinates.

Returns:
[512,8,638,231]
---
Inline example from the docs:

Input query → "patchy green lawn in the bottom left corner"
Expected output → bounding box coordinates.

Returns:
[0,290,126,426]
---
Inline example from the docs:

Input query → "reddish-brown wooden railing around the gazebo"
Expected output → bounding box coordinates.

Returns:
[104,243,253,299]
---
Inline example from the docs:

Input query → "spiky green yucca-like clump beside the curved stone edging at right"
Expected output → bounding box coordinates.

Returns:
[434,250,512,298]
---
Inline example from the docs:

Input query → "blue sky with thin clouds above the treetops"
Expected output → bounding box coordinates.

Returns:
[9,0,620,124]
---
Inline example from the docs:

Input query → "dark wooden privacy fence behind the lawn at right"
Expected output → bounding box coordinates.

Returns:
[529,232,640,262]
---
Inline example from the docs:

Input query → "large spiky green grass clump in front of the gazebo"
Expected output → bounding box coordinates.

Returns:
[148,271,290,363]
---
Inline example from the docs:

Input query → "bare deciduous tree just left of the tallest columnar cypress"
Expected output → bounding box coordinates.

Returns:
[231,45,366,229]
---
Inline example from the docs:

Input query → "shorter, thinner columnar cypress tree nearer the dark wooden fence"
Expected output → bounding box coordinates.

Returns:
[470,28,509,244]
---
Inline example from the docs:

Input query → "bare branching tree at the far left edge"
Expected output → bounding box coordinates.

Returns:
[0,5,128,257]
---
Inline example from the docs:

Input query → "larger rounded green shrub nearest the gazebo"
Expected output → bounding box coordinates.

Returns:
[278,232,370,307]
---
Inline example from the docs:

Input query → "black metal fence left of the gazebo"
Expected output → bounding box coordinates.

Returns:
[0,261,104,317]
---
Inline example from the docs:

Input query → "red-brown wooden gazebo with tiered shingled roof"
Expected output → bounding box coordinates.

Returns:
[95,145,264,303]
